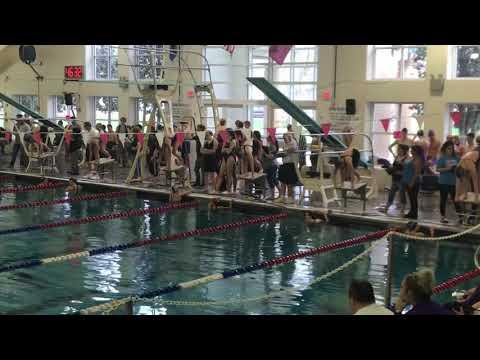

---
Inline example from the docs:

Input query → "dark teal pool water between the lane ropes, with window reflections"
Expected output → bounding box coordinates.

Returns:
[0,182,476,315]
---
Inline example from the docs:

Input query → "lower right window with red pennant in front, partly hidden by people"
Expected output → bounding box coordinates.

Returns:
[370,103,423,161]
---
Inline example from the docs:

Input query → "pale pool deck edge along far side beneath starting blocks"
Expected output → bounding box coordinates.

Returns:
[0,169,480,242]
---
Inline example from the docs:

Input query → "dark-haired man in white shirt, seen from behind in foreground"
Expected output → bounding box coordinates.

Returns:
[348,280,393,315]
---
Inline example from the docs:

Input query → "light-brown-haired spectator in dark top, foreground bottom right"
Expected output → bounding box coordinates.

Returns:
[395,269,455,315]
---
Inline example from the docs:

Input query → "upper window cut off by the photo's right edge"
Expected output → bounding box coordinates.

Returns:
[452,45,480,78]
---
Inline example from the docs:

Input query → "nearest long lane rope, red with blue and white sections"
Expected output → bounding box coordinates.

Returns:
[76,229,391,315]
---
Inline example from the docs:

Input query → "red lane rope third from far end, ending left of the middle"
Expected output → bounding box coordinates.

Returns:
[0,202,198,235]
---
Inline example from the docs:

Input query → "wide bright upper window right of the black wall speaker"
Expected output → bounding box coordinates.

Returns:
[371,45,427,80]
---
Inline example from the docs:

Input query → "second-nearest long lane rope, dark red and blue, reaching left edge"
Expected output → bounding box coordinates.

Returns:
[0,212,287,273]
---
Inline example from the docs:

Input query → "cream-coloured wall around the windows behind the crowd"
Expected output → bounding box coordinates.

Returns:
[0,45,480,139]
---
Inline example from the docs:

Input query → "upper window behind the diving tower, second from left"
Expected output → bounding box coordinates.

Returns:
[135,45,168,80]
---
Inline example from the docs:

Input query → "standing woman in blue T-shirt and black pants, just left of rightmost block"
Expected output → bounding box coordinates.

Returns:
[437,141,460,224]
